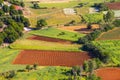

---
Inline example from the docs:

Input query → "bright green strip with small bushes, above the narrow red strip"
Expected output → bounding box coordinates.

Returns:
[30,28,84,41]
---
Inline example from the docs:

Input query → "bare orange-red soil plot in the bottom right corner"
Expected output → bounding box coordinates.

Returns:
[95,68,120,80]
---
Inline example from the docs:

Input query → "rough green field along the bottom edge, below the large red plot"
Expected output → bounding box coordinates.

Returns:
[12,67,70,80]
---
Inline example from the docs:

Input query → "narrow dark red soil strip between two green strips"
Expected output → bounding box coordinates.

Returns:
[28,35,73,44]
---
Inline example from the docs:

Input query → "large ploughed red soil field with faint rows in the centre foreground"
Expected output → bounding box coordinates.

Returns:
[13,50,90,67]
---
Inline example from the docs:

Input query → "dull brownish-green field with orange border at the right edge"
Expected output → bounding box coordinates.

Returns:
[97,28,120,40]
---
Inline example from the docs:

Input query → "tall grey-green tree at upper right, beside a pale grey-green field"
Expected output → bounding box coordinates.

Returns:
[104,10,115,23]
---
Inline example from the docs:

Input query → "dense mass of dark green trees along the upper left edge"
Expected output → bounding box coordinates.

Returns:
[0,0,30,44]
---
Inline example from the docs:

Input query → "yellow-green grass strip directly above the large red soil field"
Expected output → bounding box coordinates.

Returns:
[10,39,81,51]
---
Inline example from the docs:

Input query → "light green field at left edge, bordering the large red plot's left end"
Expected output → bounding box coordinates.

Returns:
[0,48,25,72]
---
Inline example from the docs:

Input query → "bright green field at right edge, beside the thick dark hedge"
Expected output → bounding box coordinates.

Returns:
[92,40,120,64]
